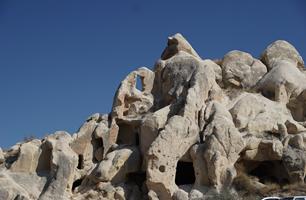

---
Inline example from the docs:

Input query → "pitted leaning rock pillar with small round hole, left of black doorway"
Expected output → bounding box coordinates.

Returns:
[147,115,199,199]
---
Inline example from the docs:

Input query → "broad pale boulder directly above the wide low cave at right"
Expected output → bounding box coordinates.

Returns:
[230,93,305,137]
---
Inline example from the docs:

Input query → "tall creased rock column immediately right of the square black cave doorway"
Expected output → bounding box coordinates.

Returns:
[203,102,245,190]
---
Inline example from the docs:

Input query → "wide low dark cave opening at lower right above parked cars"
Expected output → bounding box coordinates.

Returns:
[248,161,289,185]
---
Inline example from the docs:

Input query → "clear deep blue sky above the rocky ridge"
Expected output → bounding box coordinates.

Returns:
[0,0,306,148]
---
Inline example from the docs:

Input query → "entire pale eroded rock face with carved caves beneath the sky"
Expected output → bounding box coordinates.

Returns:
[0,34,306,200]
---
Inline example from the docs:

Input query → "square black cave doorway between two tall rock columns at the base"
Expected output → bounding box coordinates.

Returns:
[175,161,195,186]
